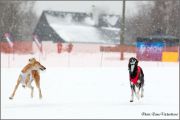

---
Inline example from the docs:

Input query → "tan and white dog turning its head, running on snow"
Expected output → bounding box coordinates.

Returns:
[9,58,46,99]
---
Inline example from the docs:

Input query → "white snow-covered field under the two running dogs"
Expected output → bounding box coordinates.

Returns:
[1,53,179,119]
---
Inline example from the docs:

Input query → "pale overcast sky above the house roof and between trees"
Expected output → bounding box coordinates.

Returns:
[34,1,150,16]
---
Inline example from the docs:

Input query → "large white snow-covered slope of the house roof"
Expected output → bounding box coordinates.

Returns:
[46,14,119,43]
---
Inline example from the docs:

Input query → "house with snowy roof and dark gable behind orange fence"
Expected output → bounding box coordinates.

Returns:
[34,11,120,44]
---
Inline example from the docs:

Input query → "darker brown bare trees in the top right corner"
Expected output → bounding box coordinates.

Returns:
[150,0,180,37]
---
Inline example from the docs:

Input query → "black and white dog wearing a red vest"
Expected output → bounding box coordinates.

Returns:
[128,57,144,102]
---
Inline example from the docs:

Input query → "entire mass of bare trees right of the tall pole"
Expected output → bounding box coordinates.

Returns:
[127,0,180,39]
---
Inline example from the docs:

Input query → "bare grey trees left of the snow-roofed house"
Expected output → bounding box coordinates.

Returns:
[0,1,37,40]
